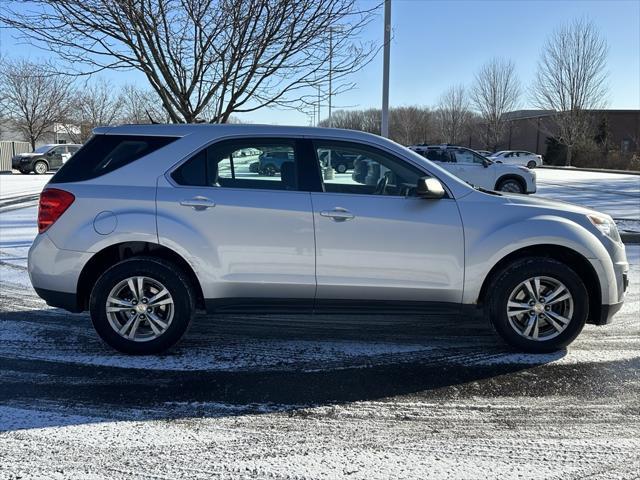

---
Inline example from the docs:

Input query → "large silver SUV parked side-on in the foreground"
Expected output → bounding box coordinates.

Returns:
[29,125,628,354]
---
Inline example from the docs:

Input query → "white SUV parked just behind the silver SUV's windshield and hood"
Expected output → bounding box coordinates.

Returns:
[409,145,536,193]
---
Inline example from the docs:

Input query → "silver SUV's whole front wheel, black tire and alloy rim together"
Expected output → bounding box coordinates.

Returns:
[487,257,589,353]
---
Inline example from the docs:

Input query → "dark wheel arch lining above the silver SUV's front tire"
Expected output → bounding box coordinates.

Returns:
[477,244,602,323]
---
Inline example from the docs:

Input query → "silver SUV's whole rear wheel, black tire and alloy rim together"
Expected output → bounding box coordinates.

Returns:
[90,257,195,355]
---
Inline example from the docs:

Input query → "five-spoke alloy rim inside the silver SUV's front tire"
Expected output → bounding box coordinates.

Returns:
[507,276,574,341]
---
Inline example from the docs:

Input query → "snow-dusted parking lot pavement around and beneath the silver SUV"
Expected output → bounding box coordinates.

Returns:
[0,170,640,480]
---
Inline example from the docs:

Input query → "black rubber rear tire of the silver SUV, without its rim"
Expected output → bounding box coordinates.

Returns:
[89,257,195,355]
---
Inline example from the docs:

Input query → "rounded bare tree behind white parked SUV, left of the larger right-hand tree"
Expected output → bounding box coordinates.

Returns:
[471,58,520,151]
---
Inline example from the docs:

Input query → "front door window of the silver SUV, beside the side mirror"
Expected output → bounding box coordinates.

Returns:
[314,141,425,196]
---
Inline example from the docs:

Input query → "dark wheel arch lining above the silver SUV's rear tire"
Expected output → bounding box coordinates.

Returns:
[77,241,204,310]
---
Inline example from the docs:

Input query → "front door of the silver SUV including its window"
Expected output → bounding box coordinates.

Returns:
[311,140,464,308]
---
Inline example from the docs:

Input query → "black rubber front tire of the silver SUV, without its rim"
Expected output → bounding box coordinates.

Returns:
[486,257,589,353]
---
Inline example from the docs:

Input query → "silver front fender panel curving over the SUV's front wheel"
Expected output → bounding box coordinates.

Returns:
[463,215,617,304]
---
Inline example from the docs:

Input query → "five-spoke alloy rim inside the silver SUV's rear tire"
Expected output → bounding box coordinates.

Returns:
[105,276,174,342]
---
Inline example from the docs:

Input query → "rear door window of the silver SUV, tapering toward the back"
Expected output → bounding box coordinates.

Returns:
[171,139,298,190]
